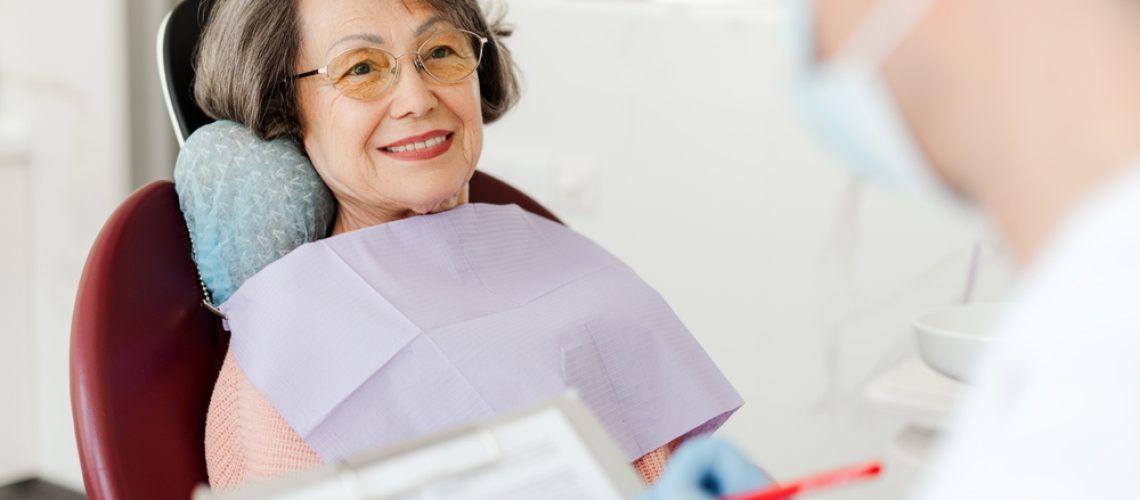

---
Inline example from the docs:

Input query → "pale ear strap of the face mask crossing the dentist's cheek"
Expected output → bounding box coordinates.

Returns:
[832,0,938,67]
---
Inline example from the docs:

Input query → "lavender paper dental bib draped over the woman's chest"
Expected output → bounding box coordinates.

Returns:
[221,205,741,461]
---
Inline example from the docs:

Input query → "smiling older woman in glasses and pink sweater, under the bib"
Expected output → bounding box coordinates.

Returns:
[188,0,739,489]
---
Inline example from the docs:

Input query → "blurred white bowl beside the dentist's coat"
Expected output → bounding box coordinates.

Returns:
[912,304,1004,382]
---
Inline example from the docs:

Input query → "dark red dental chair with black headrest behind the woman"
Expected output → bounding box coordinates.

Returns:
[71,0,557,499]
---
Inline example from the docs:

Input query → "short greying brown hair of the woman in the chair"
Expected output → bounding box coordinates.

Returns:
[194,0,519,139]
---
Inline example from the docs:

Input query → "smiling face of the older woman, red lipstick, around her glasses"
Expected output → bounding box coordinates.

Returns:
[296,0,483,233]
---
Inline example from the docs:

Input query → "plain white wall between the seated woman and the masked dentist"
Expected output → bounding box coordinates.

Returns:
[482,0,1008,499]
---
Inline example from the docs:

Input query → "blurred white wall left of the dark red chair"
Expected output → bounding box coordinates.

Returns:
[0,0,129,489]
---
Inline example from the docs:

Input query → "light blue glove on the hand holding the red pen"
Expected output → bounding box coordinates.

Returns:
[641,437,772,500]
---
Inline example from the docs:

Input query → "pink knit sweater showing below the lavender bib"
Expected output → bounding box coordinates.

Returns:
[205,353,679,490]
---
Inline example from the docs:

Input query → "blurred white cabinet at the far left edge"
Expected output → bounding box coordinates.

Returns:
[0,115,35,484]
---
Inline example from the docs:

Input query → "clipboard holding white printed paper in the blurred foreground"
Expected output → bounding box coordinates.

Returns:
[194,391,645,500]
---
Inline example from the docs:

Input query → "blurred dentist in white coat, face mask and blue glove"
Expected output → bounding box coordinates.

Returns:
[646,0,1140,500]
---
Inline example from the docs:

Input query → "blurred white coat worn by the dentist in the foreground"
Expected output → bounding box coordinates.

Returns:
[917,167,1140,500]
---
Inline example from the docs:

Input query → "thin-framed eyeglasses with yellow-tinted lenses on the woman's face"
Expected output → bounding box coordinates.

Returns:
[293,30,487,100]
